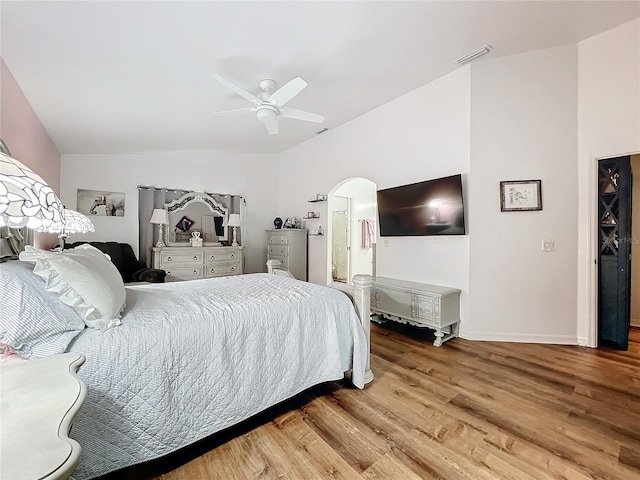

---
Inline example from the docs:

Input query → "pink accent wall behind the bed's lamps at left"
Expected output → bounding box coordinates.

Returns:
[0,58,60,248]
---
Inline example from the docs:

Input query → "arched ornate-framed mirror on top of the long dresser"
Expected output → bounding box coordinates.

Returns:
[164,192,229,247]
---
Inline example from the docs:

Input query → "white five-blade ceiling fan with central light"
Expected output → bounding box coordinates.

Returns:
[213,74,324,135]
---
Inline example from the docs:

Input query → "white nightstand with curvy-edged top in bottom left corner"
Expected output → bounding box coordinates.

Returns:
[0,353,86,480]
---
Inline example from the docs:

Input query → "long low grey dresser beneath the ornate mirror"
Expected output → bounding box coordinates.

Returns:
[151,246,243,281]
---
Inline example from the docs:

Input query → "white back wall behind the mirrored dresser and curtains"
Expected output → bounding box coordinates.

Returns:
[61,153,278,272]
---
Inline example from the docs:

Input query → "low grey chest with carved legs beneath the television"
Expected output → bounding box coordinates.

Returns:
[371,277,460,347]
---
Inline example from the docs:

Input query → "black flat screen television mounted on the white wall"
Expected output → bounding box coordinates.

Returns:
[377,175,465,237]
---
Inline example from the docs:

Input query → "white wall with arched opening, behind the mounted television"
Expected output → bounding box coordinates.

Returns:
[280,67,470,330]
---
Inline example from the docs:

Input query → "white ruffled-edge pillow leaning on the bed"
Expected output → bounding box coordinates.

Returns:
[20,244,126,328]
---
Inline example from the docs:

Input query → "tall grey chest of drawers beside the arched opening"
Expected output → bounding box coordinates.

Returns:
[266,228,307,282]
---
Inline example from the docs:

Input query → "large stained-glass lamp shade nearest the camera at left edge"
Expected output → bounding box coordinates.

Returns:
[0,152,64,231]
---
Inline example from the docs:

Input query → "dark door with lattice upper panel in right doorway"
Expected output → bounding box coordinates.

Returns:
[598,156,632,350]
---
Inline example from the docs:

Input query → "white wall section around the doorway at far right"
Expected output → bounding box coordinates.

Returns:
[577,19,640,346]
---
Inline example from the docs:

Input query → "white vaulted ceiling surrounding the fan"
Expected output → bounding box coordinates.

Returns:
[0,0,640,154]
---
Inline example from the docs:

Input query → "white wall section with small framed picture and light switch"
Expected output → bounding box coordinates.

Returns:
[466,46,578,344]
